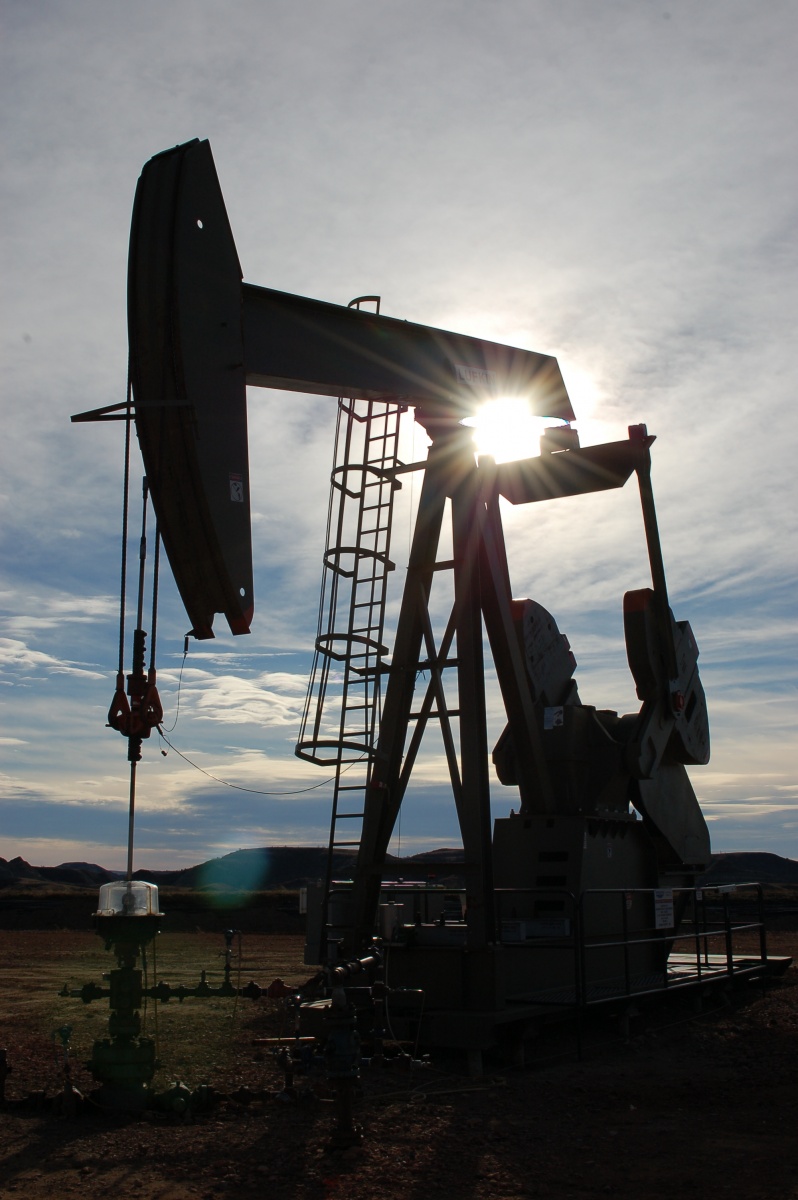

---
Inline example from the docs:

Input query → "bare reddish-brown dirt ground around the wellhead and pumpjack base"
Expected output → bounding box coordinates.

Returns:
[0,930,798,1200]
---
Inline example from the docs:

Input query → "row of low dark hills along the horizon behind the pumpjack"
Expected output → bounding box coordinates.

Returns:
[0,846,798,892]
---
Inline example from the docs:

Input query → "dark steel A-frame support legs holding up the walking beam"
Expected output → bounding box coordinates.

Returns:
[338,421,552,953]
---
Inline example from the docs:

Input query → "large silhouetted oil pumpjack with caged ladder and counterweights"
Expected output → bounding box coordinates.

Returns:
[76,140,709,1046]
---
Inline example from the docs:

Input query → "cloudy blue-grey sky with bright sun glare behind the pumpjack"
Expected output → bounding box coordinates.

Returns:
[0,0,798,869]
